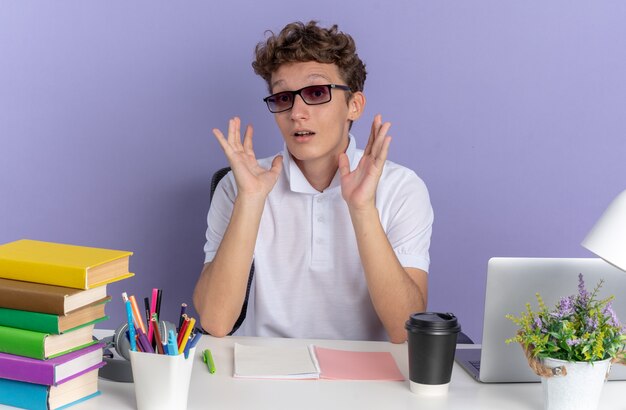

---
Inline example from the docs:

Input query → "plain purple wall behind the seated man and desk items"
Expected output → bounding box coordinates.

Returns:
[0,0,626,341]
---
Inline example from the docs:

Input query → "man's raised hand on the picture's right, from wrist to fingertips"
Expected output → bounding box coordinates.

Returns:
[339,114,391,211]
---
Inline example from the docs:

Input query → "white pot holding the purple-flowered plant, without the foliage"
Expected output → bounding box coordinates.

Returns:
[541,359,611,410]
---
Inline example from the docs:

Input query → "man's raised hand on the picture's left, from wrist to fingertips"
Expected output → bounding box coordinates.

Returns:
[213,117,283,199]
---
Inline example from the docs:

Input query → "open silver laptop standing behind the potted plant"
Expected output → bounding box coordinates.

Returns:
[455,258,626,383]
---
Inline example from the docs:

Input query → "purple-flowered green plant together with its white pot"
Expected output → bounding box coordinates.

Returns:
[506,274,626,410]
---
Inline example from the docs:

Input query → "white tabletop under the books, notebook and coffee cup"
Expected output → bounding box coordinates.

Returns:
[0,336,626,410]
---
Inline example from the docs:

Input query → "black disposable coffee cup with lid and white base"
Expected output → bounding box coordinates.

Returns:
[405,312,461,396]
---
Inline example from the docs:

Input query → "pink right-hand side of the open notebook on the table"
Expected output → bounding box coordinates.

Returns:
[315,346,404,381]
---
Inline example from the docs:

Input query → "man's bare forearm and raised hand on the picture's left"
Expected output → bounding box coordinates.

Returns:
[193,117,283,336]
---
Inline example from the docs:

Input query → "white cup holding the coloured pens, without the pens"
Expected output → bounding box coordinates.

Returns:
[129,348,196,410]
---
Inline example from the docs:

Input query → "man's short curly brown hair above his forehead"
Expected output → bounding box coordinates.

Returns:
[252,20,367,92]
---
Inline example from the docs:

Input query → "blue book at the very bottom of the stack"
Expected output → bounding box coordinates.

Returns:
[0,369,100,410]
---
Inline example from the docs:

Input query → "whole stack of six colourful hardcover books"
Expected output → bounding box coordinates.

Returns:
[0,239,133,410]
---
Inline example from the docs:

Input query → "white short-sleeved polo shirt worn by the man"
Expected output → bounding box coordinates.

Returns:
[204,136,433,340]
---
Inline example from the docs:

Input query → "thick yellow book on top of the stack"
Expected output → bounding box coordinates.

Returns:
[0,239,133,289]
